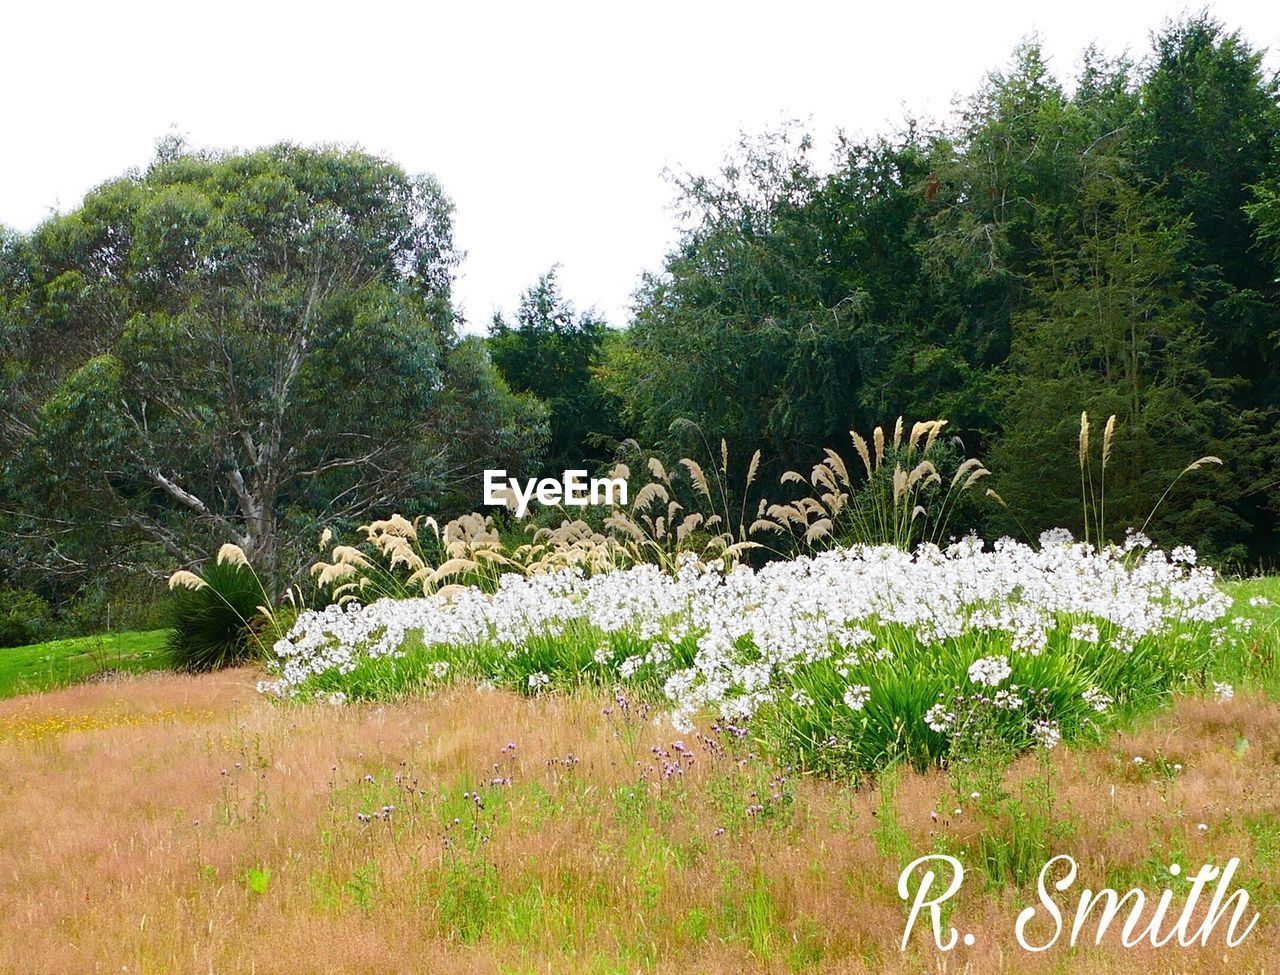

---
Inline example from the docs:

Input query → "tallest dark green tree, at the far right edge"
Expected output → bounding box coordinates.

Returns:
[1134,13,1280,559]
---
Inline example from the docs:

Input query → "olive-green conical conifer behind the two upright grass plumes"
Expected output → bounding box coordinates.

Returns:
[991,173,1244,555]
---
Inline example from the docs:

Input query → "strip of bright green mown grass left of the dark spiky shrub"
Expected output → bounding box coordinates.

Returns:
[0,630,170,699]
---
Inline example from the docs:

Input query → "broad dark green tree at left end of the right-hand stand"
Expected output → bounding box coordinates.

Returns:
[613,129,915,471]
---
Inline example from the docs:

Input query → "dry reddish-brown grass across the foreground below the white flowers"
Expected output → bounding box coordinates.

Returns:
[0,672,1280,974]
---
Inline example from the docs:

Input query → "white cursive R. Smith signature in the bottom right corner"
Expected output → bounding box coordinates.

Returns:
[897,853,1258,952]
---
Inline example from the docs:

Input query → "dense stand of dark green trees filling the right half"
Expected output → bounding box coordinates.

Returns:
[614,15,1280,562]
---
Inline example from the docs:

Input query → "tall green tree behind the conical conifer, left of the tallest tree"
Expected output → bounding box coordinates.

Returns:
[921,45,1135,438]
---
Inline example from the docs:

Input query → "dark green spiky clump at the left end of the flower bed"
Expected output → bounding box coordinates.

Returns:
[169,545,275,670]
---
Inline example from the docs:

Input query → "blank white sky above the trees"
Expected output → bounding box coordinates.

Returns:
[0,0,1280,325]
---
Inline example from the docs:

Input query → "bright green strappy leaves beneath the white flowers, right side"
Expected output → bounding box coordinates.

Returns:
[759,619,1219,774]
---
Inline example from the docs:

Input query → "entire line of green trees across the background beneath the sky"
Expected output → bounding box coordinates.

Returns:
[0,15,1280,637]
